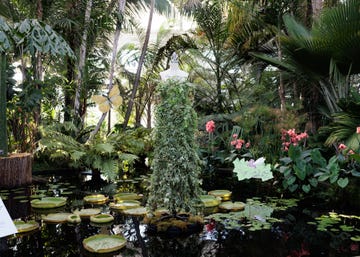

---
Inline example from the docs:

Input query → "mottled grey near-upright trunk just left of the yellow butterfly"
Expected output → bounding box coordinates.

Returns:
[74,0,92,126]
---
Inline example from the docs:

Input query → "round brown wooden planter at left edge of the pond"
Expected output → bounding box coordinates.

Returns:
[0,153,32,188]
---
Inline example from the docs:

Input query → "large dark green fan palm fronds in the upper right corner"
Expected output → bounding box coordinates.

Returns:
[252,0,360,130]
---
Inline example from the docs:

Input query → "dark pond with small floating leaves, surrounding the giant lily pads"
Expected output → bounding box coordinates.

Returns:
[0,170,360,257]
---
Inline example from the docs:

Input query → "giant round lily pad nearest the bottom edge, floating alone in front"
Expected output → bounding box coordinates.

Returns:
[83,234,126,253]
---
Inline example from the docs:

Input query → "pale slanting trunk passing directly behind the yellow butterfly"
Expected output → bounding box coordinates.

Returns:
[88,0,126,141]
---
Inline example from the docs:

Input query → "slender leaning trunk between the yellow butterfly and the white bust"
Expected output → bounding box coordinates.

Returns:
[124,0,155,129]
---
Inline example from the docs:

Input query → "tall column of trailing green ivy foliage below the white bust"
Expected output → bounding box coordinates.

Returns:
[147,79,201,215]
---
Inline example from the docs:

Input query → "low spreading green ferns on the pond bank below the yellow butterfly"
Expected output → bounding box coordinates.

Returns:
[37,124,149,181]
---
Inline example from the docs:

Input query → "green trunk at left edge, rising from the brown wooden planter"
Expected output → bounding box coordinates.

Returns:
[0,52,8,156]
